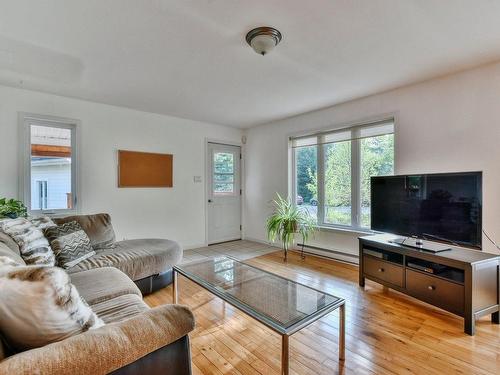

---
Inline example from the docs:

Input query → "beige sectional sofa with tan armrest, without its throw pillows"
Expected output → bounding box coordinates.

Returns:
[0,216,194,375]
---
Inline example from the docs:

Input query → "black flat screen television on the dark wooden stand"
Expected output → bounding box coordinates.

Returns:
[371,172,482,249]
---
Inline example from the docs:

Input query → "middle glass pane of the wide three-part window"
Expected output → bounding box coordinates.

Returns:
[323,141,352,225]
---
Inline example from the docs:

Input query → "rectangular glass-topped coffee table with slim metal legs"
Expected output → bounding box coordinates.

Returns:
[173,256,345,375]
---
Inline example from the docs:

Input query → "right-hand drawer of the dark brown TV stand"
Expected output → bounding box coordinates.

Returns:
[406,269,464,316]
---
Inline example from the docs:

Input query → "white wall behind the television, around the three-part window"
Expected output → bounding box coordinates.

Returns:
[244,63,500,260]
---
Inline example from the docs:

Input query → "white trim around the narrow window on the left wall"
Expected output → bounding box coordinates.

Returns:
[18,112,81,216]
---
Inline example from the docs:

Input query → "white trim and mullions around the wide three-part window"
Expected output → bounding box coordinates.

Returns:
[288,114,397,234]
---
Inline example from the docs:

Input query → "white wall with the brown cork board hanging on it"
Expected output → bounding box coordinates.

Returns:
[0,86,242,247]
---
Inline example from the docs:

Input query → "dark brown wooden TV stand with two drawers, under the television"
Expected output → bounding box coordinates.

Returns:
[359,234,500,335]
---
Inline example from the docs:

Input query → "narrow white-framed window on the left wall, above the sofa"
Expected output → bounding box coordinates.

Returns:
[21,115,77,214]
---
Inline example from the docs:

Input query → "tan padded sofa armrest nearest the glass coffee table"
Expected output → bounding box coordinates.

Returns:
[0,305,194,375]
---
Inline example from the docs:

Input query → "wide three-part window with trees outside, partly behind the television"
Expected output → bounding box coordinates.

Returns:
[291,120,394,229]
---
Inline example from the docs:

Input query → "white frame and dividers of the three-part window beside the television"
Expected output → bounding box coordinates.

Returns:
[288,115,397,233]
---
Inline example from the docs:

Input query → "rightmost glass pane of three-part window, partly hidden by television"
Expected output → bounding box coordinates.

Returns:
[360,134,394,228]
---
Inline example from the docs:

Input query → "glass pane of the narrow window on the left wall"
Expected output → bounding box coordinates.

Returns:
[30,125,73,210]
